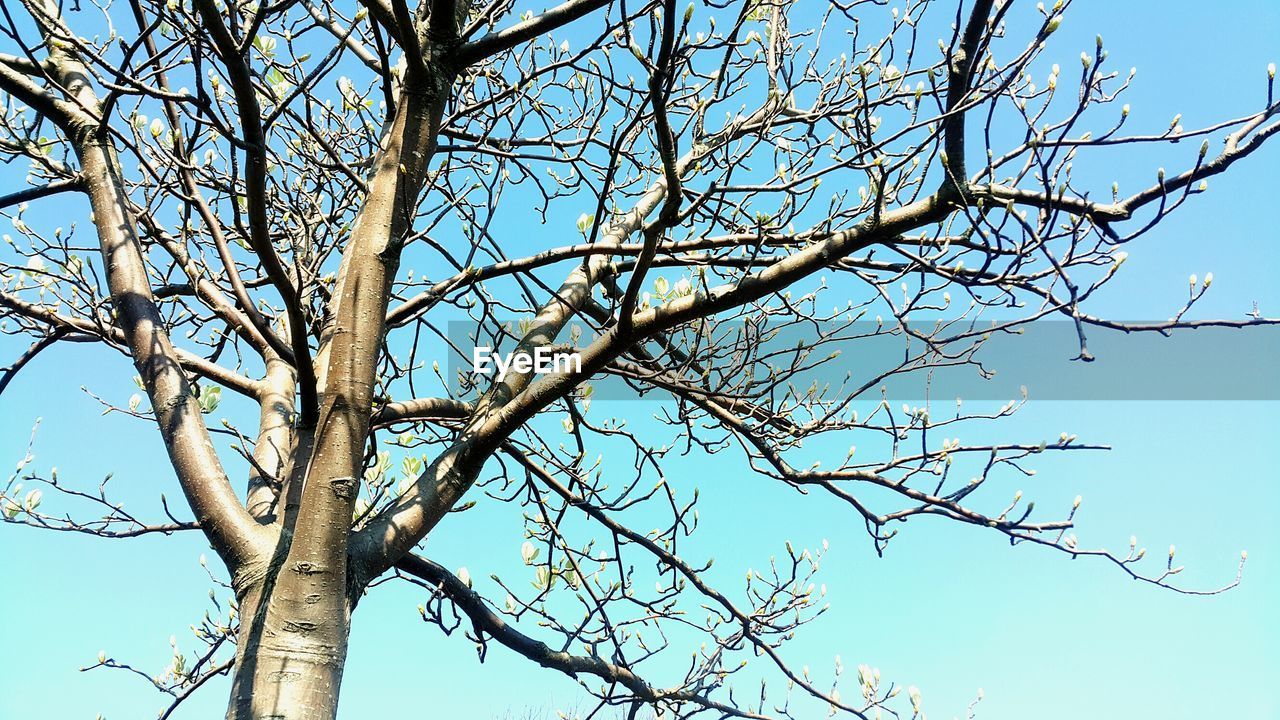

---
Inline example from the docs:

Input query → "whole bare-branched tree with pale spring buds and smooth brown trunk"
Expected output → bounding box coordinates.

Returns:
[0,0,1280,720]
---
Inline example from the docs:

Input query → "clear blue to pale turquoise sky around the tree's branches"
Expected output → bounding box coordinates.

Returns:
[0,0,1280,720]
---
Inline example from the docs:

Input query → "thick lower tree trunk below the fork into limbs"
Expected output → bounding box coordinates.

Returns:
[227,562,351,720]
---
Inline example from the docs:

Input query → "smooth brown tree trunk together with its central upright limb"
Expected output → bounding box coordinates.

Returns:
[227,51,452,720]
